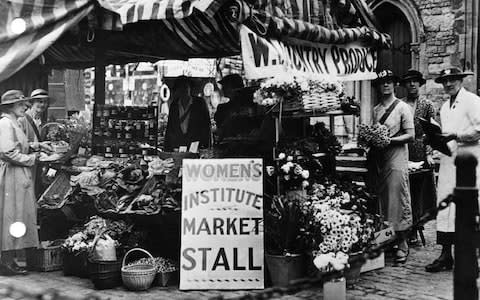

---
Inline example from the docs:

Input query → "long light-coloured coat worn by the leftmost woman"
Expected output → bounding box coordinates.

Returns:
[0,114,39,251]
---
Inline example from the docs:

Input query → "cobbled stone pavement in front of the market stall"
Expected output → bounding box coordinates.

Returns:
[0,222,470,300]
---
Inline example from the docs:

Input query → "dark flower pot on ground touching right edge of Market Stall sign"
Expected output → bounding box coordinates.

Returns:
[265,254,306,286]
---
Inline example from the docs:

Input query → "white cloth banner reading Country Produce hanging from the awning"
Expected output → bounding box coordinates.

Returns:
[240,25,377,81]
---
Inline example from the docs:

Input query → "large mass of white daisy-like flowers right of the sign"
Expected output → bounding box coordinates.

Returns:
[304,184,374,283]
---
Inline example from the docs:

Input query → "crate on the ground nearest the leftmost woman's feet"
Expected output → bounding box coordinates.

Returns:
[27,240,63,272]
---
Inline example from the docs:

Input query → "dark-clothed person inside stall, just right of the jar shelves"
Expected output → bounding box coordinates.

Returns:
[164,76,212,151]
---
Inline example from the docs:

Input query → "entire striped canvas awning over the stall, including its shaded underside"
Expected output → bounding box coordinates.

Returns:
[0,0,389,81]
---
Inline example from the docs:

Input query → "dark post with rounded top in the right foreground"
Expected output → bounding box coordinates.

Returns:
[453,152,478,300]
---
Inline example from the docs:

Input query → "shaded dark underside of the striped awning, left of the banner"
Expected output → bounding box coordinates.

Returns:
[45,13,240,68]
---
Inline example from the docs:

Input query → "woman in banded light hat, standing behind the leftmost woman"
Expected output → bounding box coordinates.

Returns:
[18,89,53,197]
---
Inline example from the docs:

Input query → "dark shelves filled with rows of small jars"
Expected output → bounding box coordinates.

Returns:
[92,105,158,158]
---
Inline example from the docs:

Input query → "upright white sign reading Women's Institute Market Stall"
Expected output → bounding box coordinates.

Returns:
[180,159,264,290]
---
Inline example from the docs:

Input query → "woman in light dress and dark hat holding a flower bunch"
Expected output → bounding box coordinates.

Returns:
[373,70,415,263]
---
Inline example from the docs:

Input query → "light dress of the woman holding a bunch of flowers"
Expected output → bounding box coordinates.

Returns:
[374,101,414,231]
